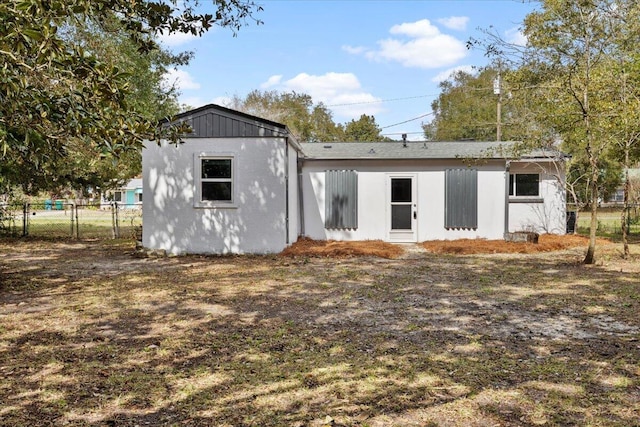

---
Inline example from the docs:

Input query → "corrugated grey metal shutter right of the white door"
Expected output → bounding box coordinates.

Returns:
[444,169,478,230]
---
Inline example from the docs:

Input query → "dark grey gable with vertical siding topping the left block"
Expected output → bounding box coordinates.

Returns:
[160,104,290,138]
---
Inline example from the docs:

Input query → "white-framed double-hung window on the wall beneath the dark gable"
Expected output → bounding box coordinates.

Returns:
[196,155,235,207]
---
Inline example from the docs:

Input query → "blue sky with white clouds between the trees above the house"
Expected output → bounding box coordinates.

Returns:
[161,0,534,140]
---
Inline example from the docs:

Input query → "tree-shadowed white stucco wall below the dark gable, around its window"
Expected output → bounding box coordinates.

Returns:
[142,138,298,254]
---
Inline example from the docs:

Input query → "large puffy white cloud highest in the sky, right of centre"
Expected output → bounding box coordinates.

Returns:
[352,19,468,69]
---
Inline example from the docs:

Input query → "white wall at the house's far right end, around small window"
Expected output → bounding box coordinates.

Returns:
[509,162,566,234]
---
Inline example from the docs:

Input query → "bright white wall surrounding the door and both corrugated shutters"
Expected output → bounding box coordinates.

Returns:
[302,160,506,241]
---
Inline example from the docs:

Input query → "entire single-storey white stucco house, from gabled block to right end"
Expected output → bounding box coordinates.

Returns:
[142,105,566,254]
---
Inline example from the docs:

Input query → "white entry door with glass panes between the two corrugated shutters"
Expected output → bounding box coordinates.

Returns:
[387,174,418,242]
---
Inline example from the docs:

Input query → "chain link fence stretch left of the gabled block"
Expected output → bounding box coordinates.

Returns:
[0,200,142,240]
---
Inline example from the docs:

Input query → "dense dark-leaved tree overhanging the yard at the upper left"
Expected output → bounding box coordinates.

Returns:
[0,0,260,196]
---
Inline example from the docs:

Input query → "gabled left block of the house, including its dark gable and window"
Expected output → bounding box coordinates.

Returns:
[142,105,300,254]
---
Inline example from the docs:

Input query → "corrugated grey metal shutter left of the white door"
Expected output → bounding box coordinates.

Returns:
[324,170,358,230]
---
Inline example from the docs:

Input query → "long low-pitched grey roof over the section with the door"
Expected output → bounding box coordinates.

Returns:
[300,141,559,160]
